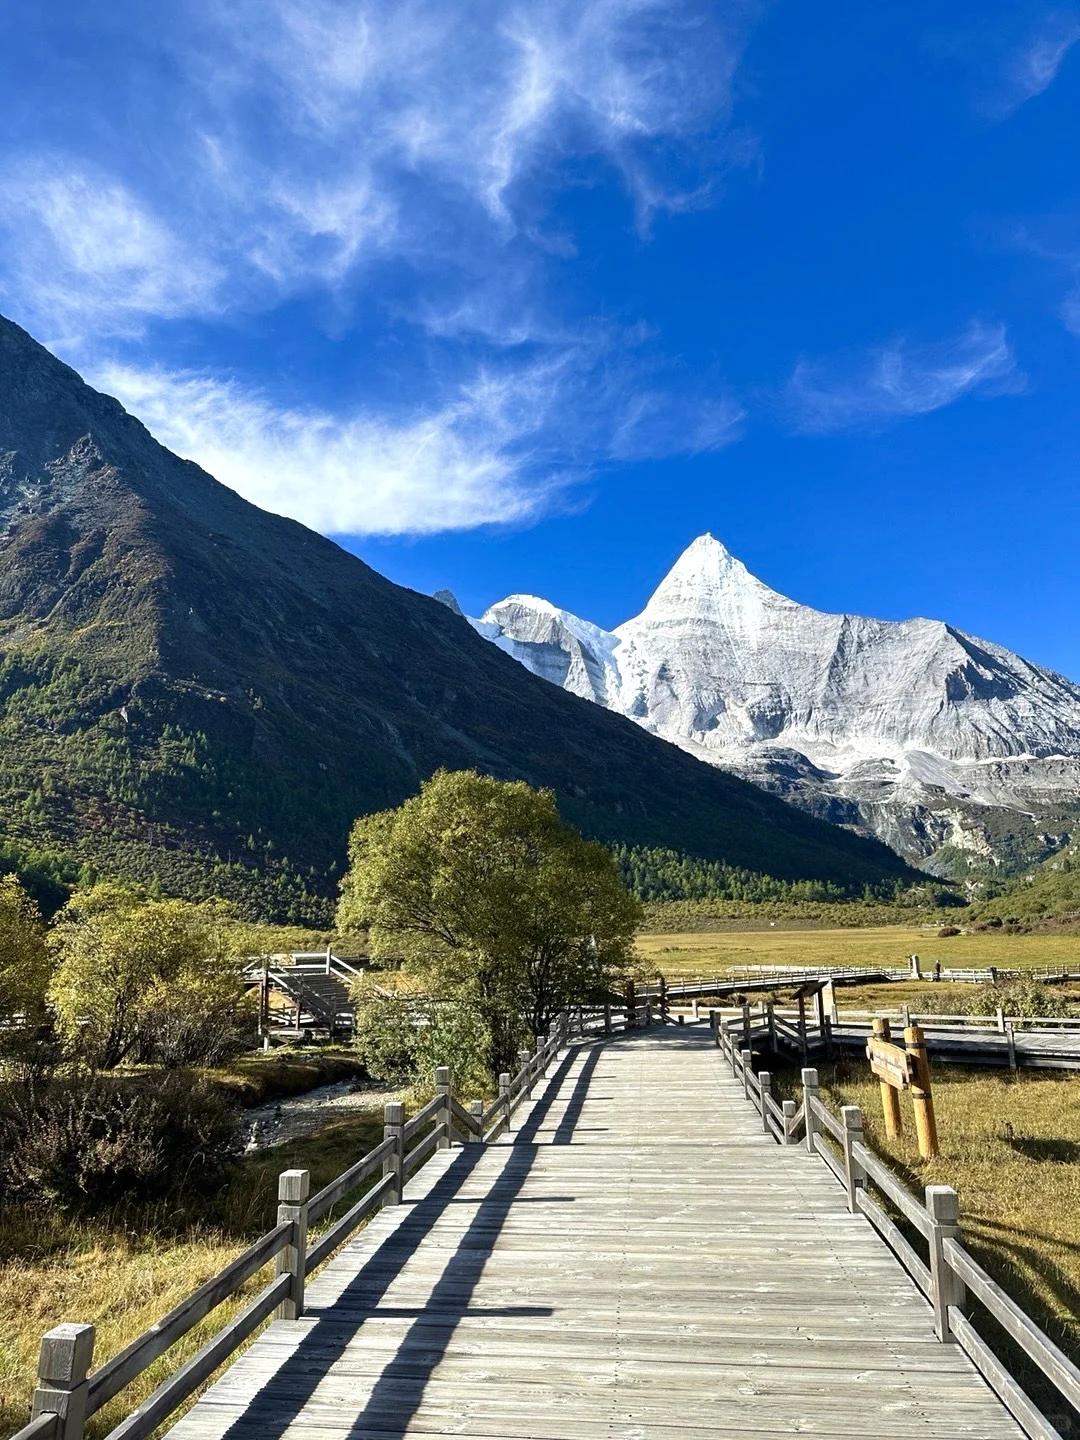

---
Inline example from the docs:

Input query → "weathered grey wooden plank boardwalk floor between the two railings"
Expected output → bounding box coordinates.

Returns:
[170,1027,1022,1440]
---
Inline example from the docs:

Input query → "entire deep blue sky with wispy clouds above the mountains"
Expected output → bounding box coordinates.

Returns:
[0,0,1080,678]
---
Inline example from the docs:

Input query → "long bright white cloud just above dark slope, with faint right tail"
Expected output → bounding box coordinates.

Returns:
[91,340,740,536]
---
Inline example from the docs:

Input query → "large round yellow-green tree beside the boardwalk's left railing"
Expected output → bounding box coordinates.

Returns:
[338,770,641,1068]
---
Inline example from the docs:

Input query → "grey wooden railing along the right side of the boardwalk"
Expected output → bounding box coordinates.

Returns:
[711,1012,1080,1440]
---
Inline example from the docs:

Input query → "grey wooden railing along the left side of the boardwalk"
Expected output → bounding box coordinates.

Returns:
[12,1011,576,1440]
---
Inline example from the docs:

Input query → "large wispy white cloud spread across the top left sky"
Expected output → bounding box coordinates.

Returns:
[0,0,756,334]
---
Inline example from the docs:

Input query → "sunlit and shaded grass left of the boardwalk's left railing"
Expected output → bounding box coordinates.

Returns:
[0,1110,383,1437]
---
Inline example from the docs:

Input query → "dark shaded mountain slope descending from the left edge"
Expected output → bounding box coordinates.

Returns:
[0,320,910,917]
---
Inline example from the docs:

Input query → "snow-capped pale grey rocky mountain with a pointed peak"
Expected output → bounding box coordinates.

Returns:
[474,536,1080,873]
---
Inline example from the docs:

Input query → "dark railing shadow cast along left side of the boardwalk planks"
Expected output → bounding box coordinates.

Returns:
[226,1045,602,1440]
